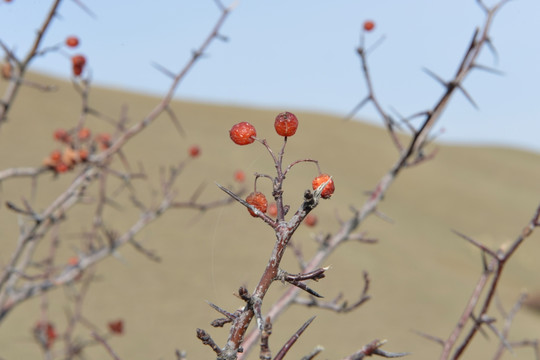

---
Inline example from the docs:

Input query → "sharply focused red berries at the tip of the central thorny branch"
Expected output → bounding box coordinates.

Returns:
[229,112,335,219]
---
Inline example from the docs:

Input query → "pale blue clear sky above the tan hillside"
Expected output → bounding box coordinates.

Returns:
[0,0,540,152]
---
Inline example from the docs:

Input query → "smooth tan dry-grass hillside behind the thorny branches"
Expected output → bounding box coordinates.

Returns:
[0,75,540,360]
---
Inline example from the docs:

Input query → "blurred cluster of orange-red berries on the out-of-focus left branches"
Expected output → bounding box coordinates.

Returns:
[43,128,111,174]
